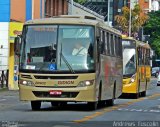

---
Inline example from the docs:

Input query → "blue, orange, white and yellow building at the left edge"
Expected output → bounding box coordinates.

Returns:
[0,0,45,89]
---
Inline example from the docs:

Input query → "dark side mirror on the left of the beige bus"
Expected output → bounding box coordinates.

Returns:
[14,36,21,55]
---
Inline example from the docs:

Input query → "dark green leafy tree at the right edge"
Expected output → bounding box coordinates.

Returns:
[144,11,160,58]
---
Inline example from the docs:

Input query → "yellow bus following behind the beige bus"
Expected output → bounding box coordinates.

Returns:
[122,37,151,98]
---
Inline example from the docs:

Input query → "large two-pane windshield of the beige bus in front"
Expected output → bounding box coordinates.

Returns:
[20,25,95,73]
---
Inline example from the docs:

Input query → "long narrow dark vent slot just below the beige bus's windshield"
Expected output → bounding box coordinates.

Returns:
[34,75,78,79]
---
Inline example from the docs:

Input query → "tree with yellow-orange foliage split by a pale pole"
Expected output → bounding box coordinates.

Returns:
[115,4,148,37]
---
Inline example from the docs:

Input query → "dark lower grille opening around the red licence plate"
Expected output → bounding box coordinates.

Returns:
[33,91,79,98]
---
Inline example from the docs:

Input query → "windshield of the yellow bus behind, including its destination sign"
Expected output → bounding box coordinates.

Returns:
[122,40,136,76]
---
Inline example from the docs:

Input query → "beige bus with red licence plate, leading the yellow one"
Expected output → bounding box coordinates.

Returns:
[15,15,123,110]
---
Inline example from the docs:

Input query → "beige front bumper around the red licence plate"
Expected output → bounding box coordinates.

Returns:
[19,85,97,102]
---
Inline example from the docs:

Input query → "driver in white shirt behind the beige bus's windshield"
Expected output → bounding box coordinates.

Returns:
[72,43,87,56]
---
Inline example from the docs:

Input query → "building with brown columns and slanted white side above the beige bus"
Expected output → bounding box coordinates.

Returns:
[45,0,104,19]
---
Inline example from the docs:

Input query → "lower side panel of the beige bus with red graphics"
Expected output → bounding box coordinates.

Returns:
[101,55,122,100]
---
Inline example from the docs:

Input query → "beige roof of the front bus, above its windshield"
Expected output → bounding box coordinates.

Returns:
[25,15,121,35]
